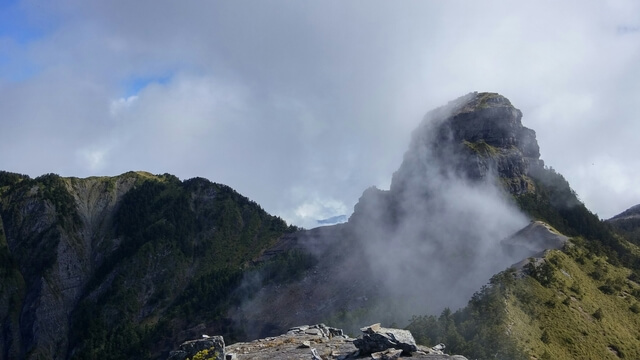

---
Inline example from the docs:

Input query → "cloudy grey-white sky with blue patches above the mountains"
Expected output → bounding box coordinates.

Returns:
[0,0,640,227]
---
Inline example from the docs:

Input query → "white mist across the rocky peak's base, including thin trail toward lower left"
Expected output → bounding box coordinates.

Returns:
[236,96,529,337]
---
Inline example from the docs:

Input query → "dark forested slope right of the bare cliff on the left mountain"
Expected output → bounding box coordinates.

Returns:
[72,174,294,359]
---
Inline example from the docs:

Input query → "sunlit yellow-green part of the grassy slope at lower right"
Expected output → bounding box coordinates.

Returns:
[506,246,640,359]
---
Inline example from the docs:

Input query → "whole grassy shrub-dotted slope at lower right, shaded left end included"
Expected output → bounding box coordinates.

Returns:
[408,241,640,360]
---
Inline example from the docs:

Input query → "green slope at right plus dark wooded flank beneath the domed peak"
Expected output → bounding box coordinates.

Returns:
[409,169,640,360]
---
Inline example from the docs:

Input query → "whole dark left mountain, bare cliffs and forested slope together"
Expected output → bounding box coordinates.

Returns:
[0,172,287,359]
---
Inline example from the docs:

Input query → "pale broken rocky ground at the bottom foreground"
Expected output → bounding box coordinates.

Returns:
[169,324,466,360]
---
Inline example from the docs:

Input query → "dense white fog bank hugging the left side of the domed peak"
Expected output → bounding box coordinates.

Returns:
[344,94,529,319]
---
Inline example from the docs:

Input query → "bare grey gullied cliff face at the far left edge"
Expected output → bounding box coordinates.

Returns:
[2,174,136,358]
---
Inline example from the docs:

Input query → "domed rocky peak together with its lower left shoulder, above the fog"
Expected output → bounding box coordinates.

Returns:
[350,93,544,233]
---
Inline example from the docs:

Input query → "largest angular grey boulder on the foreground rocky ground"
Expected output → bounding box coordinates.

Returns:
[353,324,418,355]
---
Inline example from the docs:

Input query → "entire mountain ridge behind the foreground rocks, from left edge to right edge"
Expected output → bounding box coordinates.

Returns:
[0,93,640,360]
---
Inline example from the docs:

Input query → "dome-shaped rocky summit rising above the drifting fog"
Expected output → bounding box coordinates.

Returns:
[391,92,544,195]
